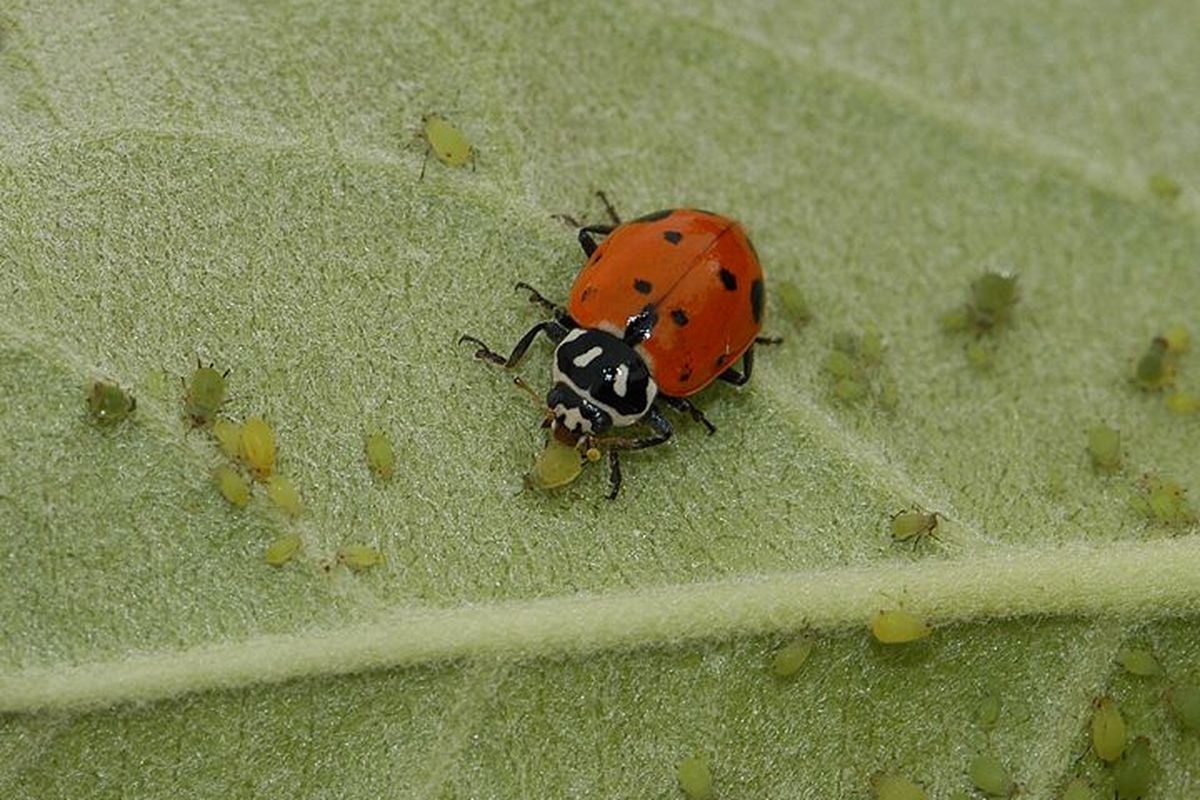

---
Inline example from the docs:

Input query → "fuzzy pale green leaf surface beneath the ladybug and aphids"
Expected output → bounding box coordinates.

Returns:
[0,0,1200,798]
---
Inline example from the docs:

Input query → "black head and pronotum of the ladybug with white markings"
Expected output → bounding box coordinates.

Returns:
[546,327,659,444]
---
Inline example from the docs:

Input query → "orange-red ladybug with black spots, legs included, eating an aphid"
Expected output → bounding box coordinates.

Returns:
[458,193,779,499]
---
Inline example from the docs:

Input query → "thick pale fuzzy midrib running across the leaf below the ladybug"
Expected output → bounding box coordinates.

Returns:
[0,535,1200,712]
